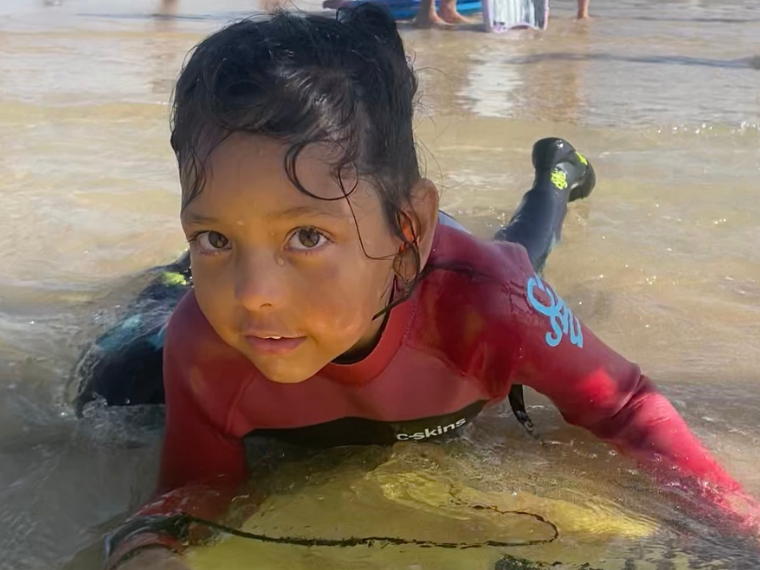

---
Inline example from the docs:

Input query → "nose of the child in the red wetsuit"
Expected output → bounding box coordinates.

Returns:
[235,250,287,311]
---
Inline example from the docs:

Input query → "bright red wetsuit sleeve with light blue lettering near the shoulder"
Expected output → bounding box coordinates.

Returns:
[510,271,756,520]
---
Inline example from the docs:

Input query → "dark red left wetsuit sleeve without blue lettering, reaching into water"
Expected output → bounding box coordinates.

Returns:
[102,300,247,569]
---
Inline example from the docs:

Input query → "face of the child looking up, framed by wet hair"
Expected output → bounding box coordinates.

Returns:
[182,135,437,383]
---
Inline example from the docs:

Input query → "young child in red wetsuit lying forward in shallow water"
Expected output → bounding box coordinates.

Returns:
[104,5,756,570]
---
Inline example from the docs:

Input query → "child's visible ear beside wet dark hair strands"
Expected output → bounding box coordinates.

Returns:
[396,178,438,280]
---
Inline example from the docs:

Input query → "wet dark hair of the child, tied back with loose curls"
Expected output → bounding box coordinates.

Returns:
[171,3,421,310]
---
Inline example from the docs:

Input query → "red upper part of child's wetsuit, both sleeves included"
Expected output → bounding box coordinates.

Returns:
[107,226,740,564]
